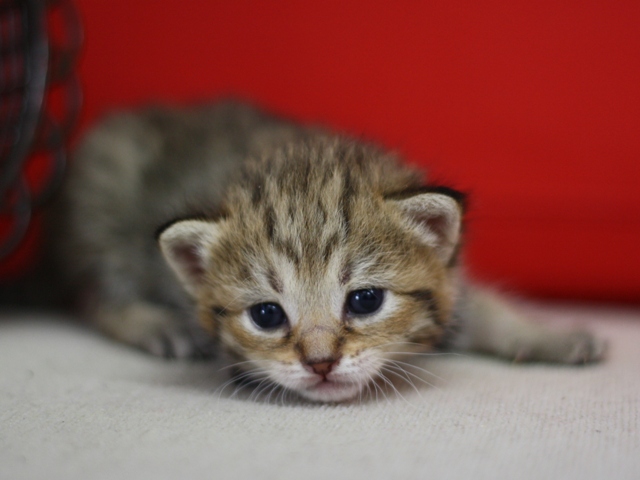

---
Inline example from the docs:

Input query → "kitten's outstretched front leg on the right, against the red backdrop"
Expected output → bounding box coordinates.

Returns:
[454,287,605,364]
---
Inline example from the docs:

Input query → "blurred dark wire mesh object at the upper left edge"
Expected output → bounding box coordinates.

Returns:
[0,0,82,268]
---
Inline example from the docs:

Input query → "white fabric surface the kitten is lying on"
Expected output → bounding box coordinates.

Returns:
[0,305,640,480]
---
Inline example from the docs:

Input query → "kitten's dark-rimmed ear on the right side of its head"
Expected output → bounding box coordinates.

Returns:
[389,187,464,265]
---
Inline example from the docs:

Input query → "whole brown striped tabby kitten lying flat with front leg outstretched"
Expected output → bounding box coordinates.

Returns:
[57,103,603,401]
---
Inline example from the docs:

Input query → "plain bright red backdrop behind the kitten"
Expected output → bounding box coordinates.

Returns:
[5,0,640,301]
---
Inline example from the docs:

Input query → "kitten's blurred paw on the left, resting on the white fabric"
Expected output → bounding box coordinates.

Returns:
[90,301,215,358]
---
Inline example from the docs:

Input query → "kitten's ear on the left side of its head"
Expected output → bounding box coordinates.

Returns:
[157,220,220,295]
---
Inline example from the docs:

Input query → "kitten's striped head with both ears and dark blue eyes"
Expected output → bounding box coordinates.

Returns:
[159,139,462,401]
